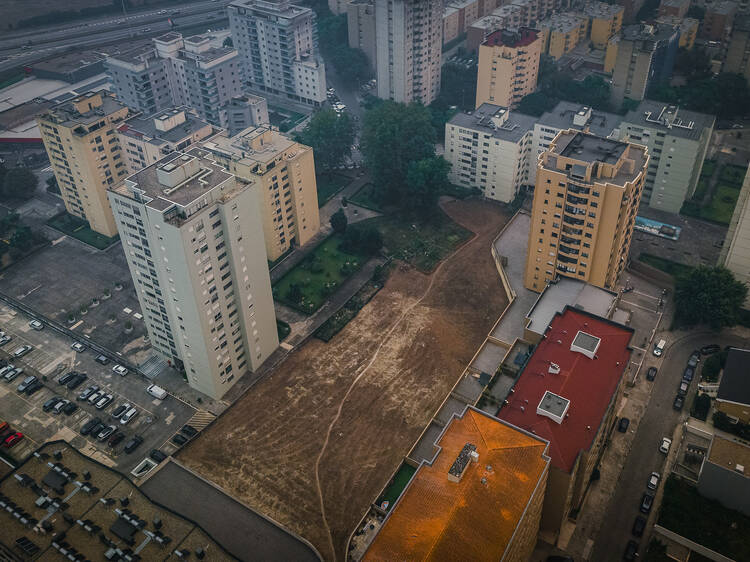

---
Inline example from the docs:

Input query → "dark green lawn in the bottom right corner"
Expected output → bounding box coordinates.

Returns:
[659,476,750,560]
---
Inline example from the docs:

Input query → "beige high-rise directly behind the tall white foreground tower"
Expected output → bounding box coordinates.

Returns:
[201,127,320,261]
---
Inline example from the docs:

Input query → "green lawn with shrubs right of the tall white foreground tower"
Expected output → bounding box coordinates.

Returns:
[273,235,367,314]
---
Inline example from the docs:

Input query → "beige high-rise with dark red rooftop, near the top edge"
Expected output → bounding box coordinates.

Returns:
[475,27,542,107]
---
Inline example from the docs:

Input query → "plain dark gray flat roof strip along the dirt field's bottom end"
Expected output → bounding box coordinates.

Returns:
[141,459,320,562]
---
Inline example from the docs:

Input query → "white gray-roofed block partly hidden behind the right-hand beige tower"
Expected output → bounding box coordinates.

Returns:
[529,101,622,185]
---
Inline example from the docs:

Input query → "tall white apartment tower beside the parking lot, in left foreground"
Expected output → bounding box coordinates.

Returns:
[109,147,279,399]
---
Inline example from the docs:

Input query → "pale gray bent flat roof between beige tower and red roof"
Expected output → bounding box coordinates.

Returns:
[527,277,617,334]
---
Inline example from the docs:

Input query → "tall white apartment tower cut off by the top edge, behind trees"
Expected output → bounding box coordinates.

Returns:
[375,0,443,105]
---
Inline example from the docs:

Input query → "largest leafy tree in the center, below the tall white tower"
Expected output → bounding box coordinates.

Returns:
[361,101,437,202]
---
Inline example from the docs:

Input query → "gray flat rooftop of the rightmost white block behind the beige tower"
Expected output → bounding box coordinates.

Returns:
[622,100,716,140]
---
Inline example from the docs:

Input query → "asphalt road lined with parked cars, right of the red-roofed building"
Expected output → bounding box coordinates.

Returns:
[588,332,747,561]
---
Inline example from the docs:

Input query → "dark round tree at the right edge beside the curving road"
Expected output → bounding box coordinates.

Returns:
[674,266,747,330]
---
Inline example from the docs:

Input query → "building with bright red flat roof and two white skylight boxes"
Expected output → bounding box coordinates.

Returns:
[497,307,633,538]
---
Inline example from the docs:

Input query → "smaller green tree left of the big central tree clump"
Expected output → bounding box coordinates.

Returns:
[297,109,356,172]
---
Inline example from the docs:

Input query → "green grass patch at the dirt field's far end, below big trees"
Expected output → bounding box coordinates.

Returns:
[363,211,471,273]
